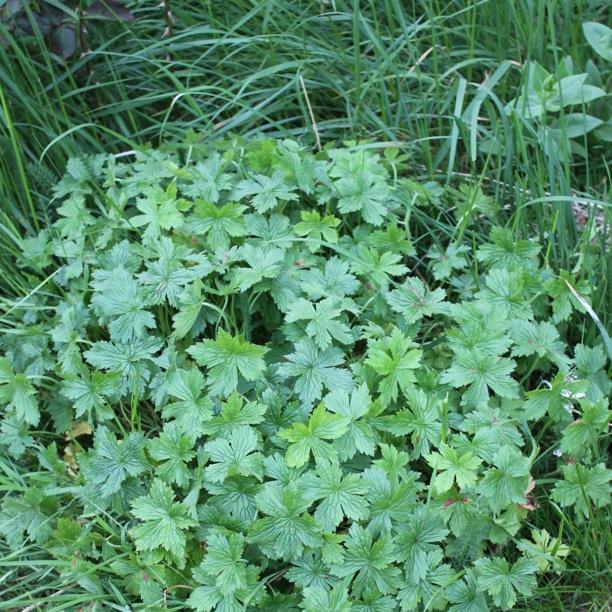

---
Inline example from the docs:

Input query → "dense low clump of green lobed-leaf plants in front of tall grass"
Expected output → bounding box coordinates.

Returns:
[0,139,612,612]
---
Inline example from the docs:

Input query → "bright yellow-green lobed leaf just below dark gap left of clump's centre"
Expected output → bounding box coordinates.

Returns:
[187,329,268,395]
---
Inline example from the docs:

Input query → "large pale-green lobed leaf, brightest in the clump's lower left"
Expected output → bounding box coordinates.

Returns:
[131,478,197,567]
